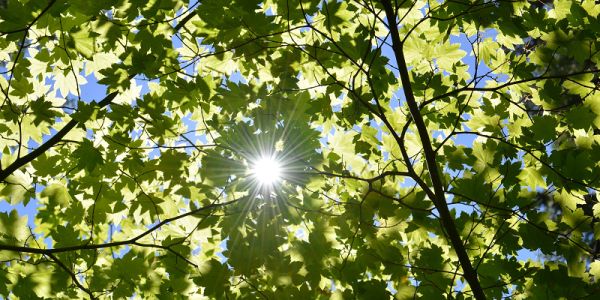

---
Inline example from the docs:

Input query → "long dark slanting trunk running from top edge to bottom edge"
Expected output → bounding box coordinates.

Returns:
[381,0,485,299]
